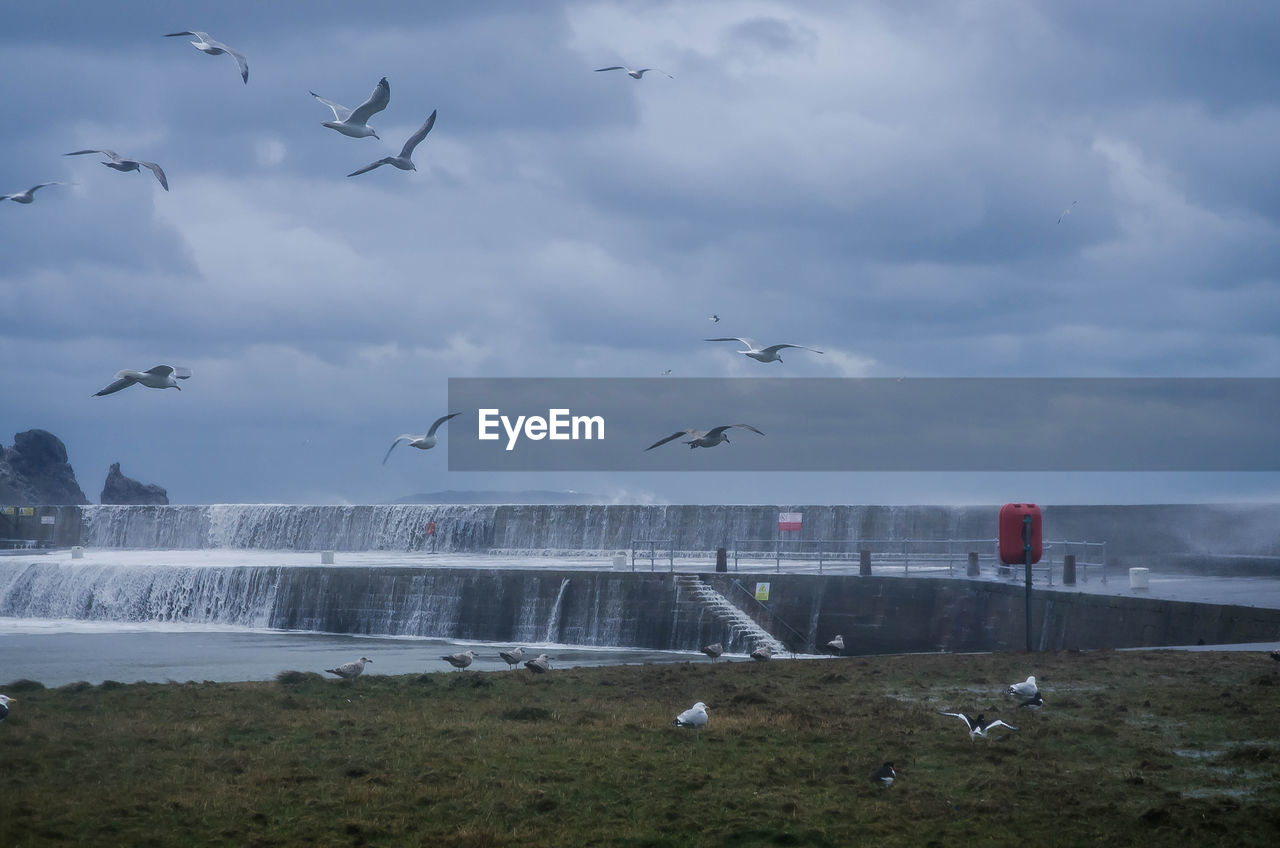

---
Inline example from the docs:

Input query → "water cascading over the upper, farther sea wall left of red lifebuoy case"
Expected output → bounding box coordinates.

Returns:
[81,503,995,556]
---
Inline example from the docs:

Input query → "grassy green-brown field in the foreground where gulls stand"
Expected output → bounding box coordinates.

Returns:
[0,652,1280,848]
